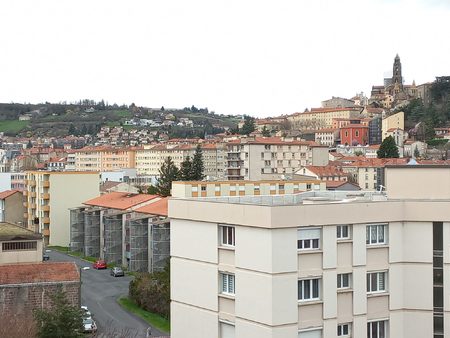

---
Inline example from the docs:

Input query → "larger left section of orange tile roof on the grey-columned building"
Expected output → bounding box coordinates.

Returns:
[83,192,159,210]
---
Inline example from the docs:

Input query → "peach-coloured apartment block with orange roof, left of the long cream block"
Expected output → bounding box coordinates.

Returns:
[74,146,136,172]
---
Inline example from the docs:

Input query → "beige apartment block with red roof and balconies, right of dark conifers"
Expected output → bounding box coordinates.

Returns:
[226,137,328,181]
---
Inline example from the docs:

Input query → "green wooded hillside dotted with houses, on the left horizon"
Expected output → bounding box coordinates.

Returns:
[0,100,239,137]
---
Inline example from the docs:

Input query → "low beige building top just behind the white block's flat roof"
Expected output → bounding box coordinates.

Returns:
[172,179,326,198]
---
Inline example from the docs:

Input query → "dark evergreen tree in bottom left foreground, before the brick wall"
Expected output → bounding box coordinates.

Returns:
[34,285,84,338]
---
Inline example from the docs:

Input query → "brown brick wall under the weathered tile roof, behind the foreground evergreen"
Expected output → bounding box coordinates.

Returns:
[0,282,80,316]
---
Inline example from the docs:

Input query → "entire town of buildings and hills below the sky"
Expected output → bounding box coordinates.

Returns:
[0,55,450,338]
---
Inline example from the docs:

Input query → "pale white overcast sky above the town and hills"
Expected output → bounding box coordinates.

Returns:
[0,0,450,116]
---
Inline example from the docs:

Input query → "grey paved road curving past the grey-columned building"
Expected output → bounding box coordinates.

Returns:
[48,250,164,338]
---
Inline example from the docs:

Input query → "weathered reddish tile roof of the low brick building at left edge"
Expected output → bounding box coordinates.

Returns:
[0,262,80,285]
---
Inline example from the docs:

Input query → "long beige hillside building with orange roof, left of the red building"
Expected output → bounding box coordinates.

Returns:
[288,107,365,130]
